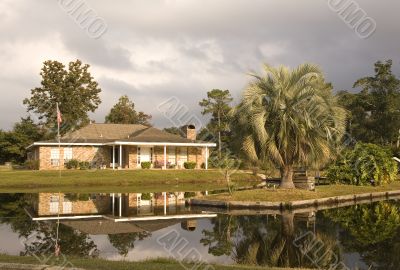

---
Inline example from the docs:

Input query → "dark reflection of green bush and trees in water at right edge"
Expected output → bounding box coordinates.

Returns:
[323,201,400,270]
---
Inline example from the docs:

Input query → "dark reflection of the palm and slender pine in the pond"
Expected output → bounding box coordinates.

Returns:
[201,212,337,268]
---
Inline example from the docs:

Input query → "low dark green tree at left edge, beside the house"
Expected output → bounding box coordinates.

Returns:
[0,117,48,163]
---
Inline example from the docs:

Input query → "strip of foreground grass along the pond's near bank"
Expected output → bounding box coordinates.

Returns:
[0,255,310,270]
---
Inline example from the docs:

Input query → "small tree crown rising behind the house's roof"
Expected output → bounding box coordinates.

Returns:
[106,95,151,126]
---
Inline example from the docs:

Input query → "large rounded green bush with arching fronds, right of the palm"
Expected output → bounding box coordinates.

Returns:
[327,143,397,186]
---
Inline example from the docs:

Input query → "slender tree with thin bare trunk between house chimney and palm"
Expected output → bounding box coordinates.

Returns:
[199,89,233,158]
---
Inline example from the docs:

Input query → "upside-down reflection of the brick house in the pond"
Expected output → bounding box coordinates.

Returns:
[26,192,216,234]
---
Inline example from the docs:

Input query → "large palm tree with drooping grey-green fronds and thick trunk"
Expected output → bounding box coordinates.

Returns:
[236,64,346,188]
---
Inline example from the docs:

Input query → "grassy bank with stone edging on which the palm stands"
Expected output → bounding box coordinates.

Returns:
[206,181,400,202]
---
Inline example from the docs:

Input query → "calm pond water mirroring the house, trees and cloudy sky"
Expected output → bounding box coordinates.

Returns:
[0,192,400,269]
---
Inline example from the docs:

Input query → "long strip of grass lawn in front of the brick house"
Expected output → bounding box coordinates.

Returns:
[0,170,260,193]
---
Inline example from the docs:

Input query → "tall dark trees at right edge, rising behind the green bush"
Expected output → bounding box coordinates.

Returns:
[339,60,400,147]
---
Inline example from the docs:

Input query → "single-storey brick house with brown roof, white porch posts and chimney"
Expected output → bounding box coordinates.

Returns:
[28,123,216,170]
